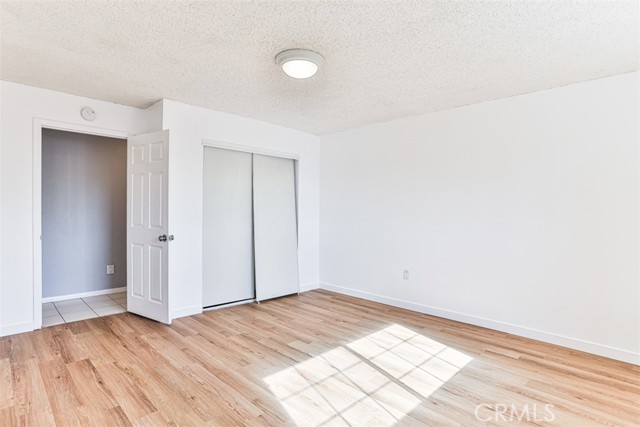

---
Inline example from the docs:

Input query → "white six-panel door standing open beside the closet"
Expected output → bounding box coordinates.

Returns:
[127,130,173,323]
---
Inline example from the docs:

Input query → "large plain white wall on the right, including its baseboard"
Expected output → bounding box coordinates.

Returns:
[320,73,640,363]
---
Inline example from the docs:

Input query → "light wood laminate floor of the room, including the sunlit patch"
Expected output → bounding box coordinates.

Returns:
[0,291,640,427]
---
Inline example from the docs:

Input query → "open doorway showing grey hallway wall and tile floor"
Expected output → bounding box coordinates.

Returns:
[39,126,127,326]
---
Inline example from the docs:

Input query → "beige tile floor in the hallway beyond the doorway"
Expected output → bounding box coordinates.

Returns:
[42,292,127,328]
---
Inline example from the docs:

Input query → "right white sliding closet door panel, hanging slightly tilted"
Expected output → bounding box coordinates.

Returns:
[253,154,299,301]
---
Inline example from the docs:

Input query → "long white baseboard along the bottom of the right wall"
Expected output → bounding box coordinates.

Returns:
[320,283,640,365]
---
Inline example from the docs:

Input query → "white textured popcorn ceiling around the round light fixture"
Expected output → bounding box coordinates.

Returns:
[0,0,640,134]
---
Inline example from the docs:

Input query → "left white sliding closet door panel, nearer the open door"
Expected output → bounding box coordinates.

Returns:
[202,147,254,307]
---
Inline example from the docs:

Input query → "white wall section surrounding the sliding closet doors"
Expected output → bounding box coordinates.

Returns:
[162,100,319,318]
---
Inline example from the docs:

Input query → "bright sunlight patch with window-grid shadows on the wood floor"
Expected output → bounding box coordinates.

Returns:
[264,324,472,426]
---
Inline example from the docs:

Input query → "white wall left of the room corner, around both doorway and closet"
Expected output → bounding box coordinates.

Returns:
[0,81,319,336]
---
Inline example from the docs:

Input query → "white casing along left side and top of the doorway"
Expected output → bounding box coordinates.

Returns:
[33,117,129,331]
